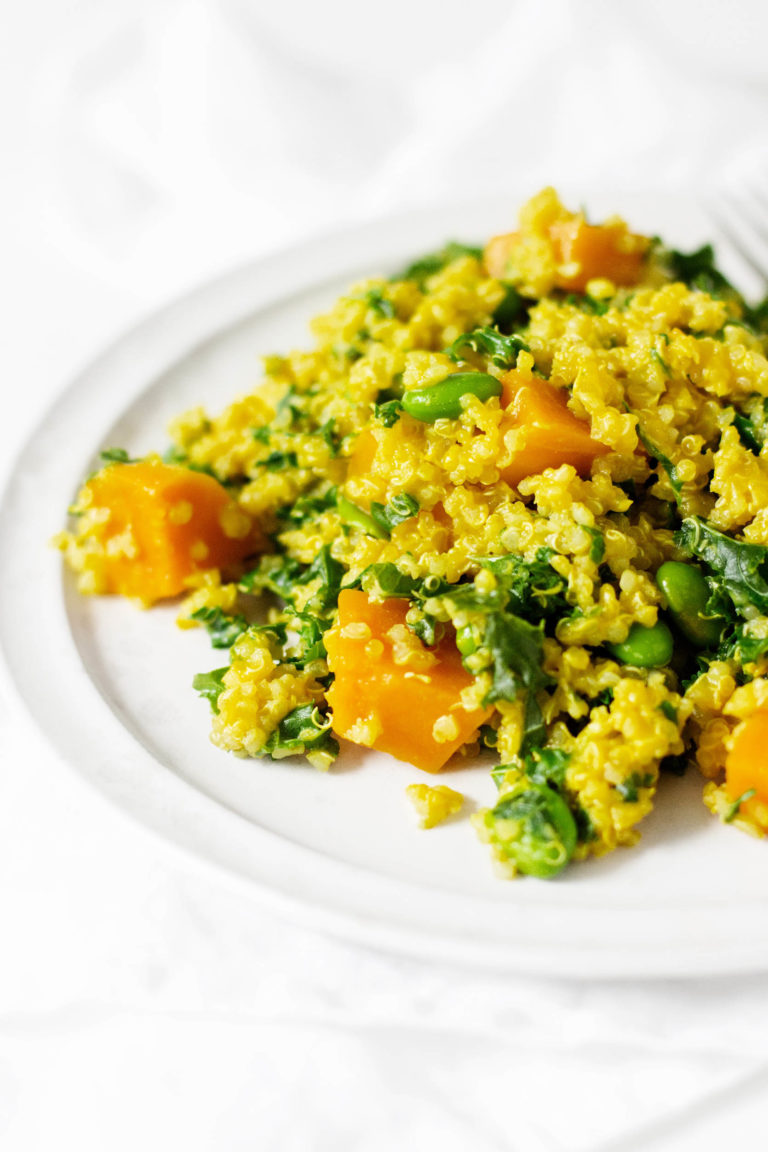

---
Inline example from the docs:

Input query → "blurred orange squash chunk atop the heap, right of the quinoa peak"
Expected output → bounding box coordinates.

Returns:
[549,215,648,291]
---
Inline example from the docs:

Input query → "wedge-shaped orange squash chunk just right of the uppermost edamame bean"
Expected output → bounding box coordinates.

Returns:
[500,371,608,485]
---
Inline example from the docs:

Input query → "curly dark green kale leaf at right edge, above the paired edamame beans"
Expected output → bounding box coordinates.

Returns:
[675,516,768,614]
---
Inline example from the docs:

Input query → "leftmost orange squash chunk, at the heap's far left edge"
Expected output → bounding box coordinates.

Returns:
[79,458,265,605]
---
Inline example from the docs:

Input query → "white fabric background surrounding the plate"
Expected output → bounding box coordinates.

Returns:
[0,0,768,1152]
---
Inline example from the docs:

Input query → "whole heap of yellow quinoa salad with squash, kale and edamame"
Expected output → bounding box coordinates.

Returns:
[59,189,768,878]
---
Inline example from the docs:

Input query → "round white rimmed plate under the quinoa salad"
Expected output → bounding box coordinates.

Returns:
[0,186,768,976]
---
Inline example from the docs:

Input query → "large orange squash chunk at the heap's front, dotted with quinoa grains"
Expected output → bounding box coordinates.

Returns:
[325,589,493,772]
